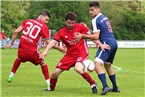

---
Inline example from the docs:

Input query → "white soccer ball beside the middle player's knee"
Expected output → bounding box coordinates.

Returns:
[83,60,95,72]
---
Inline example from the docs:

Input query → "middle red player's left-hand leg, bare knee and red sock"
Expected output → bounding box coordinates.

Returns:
[50,68,64,91]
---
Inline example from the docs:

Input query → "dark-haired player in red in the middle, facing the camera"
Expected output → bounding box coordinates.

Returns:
[40,12,98,94]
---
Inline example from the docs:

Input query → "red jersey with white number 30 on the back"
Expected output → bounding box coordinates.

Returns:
[19,19,49,51]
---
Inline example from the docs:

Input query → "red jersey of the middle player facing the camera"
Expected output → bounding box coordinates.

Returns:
[54,23,88,54]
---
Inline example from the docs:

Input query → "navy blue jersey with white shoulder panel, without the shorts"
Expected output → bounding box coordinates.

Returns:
[92,13,116,43]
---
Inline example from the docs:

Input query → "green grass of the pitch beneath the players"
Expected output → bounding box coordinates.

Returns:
[1,48,145,97]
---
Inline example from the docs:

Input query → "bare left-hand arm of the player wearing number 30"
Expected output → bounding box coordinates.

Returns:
[4,26,23,48]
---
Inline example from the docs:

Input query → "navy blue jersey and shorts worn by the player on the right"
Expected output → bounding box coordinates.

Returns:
[92,13,118,64]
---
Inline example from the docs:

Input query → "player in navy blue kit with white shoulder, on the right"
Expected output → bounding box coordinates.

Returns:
[75,1,120,95]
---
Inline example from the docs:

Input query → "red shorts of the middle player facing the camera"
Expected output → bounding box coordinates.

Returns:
[56,54,88,70]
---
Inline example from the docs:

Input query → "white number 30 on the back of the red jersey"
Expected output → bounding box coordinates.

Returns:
[23,22,41,39]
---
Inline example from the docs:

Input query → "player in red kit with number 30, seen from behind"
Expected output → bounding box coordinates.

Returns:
[5,11,63,89]
